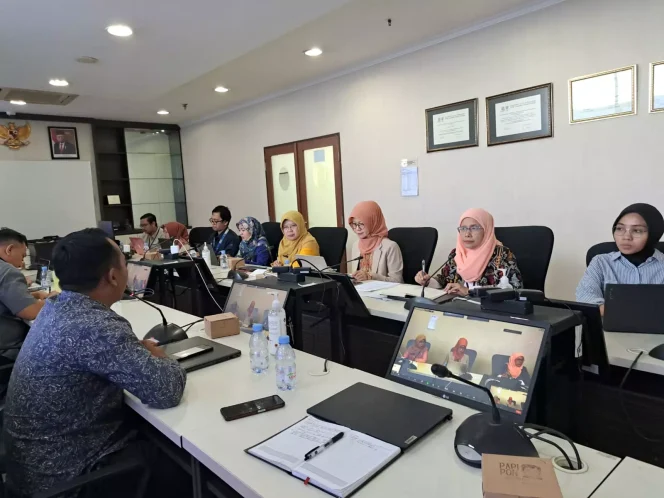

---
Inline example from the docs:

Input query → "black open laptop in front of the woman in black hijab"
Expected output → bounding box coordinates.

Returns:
[604,284,664,334]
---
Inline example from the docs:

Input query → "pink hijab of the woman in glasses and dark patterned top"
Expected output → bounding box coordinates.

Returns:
[454,208,502,282]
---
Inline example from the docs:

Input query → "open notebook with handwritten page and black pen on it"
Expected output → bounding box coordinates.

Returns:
[246,416,401,498]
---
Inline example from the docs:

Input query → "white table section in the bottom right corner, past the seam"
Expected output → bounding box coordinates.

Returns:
[592,457,664,498]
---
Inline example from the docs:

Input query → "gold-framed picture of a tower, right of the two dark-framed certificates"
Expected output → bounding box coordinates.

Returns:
[569,64,637,124]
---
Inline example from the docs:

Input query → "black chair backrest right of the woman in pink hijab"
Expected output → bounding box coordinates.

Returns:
[496,226,553,291]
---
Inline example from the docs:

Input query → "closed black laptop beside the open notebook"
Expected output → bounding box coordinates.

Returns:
[307,382,452,450]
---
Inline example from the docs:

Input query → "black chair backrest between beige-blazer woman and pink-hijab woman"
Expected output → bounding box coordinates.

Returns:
[387,227,438,284]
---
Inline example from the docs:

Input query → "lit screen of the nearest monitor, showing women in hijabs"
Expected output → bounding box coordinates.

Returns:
[387,308,545,419]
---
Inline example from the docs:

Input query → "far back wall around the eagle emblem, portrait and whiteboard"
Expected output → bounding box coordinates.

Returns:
[0,118,101,221]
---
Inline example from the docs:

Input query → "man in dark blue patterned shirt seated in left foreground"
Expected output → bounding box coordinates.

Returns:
[3,229,186,497]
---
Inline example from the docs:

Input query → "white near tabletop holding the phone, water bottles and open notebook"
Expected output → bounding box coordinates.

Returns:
[113,301,620,498]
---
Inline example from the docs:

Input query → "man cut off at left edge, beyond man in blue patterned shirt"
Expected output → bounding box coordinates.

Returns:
[0,228,48,360]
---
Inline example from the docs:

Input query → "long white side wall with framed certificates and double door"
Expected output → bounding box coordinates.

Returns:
[181,0,664,298]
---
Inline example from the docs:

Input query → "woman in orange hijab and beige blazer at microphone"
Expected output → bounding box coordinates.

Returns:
[348,201,403,283]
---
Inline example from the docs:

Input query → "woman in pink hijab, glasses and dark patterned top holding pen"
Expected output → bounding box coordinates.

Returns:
[415,208,523,296]
